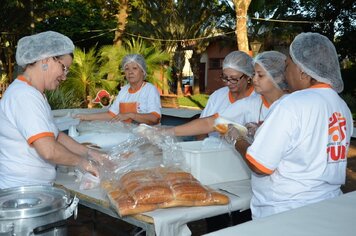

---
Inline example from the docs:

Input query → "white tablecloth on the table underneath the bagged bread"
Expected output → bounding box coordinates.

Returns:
[55,173,252,236]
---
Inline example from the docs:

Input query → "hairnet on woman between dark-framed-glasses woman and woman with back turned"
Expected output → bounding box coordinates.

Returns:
[253,51,287,89]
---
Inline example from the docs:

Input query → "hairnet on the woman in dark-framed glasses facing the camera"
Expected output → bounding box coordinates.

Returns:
[223,51,254,77]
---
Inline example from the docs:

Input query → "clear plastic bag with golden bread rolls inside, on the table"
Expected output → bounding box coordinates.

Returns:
[92,125,229,216]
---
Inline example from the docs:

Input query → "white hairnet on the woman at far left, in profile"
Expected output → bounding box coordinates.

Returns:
[16,31,74,67]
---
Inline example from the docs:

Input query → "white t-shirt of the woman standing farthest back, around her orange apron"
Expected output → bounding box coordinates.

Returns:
[109,82,161,118]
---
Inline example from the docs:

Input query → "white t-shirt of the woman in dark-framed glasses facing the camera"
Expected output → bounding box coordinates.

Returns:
[200,86,256,137]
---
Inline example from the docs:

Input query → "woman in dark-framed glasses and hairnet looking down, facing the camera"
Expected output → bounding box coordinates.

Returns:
[197,51,254,139]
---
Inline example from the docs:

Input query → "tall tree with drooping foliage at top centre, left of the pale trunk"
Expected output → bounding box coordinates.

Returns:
[127,0,231,95]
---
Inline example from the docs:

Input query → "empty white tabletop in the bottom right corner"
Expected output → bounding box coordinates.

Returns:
[207,191,356,236]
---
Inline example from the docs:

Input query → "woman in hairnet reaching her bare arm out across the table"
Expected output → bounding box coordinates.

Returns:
[171,51,286,140]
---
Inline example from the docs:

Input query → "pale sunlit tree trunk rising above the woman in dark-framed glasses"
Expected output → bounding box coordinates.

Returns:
[233,0,251,53]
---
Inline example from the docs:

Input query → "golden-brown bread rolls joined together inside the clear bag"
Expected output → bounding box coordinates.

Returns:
[102,168,229,216]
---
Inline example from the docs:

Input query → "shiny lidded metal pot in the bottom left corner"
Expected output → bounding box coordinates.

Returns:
[0,186,79,236]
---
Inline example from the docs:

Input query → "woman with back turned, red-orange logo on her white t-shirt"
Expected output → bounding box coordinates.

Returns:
[229,33,353,219]
